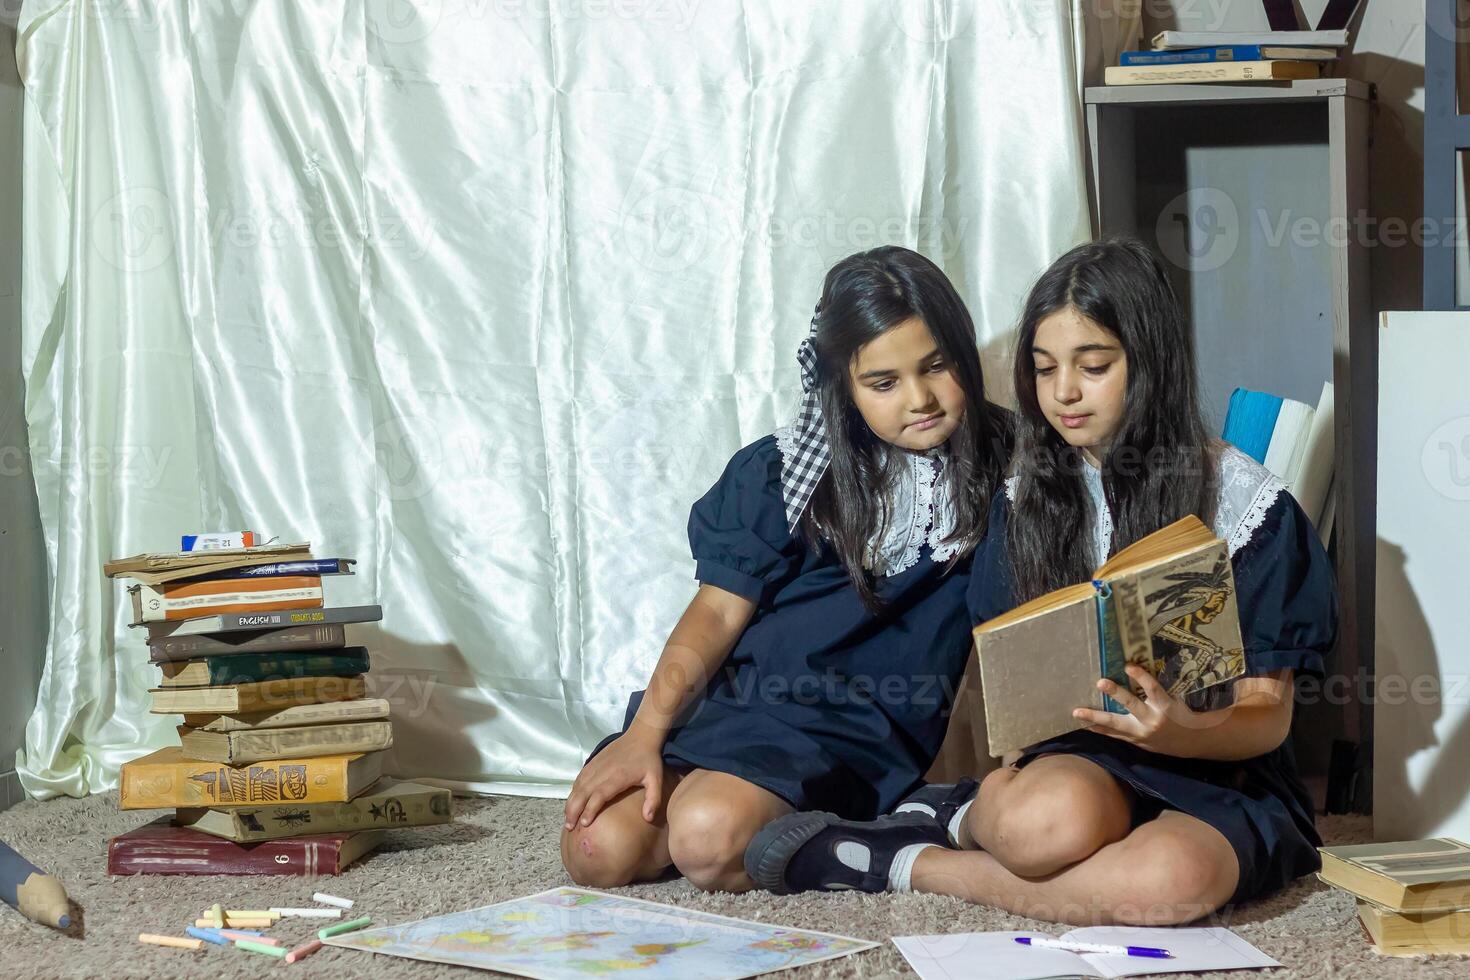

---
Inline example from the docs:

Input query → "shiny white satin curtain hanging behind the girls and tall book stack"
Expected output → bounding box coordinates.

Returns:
[18,0,1132,796]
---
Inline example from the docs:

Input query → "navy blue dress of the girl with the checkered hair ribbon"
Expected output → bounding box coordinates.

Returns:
[592,436,970,820]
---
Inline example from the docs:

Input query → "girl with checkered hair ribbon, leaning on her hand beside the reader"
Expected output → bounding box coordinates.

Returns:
[562,247,1010,890]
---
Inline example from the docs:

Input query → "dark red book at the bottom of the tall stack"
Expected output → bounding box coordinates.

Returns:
[107,817,384,876]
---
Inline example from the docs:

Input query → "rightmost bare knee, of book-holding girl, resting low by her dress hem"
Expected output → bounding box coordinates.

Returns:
[1113,835,1239,926]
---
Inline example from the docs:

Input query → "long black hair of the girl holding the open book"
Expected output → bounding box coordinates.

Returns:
[1007,238,1217,602]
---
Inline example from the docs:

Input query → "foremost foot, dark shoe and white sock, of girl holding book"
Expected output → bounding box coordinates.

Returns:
[745,813,948,895]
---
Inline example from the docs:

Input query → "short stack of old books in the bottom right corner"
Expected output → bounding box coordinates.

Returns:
[1317,837,1470,956]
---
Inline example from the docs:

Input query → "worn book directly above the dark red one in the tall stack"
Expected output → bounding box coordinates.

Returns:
[173,779,454,843]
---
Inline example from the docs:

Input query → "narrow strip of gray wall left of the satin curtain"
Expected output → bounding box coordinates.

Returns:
[0,0,47,810]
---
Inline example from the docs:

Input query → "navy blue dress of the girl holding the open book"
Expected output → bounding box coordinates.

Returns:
[969,491,1338,902]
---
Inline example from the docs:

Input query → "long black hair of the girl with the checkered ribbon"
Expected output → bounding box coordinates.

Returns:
[801,245,1010,613]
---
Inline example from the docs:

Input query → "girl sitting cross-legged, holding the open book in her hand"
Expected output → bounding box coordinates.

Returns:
[747,239,1338,924]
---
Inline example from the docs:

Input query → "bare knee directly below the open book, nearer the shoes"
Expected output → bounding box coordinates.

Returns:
[972,771,1132,877]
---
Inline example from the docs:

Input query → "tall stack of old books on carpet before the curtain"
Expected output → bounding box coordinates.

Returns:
[103,538,453,874]
